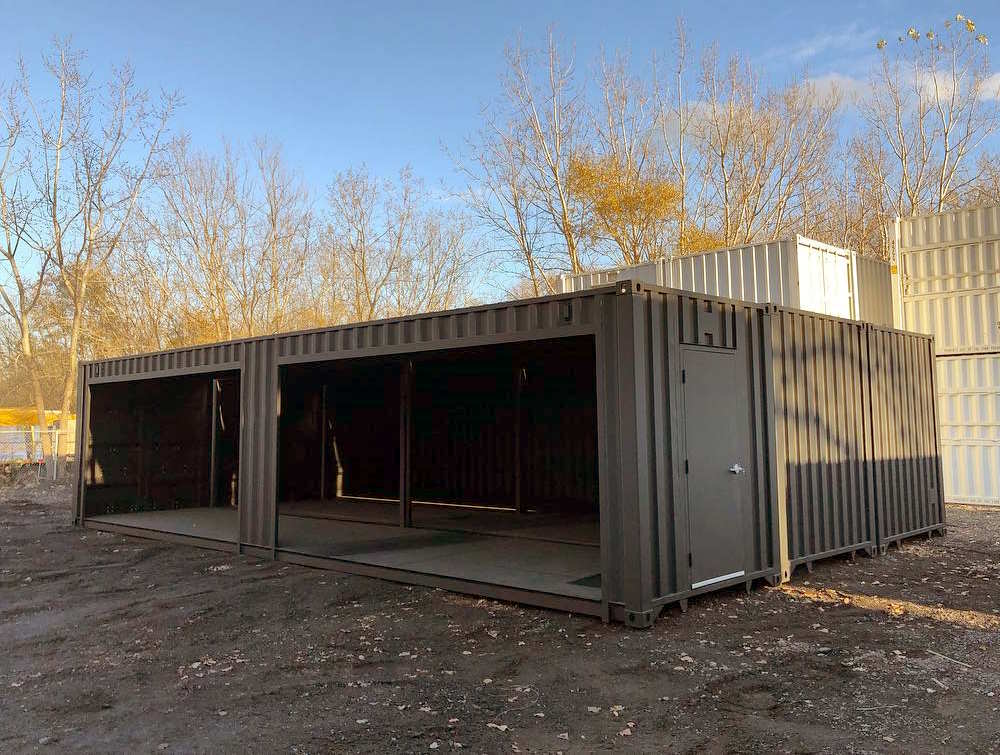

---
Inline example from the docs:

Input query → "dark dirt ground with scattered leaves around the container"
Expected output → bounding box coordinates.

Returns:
[0,488,1000,753]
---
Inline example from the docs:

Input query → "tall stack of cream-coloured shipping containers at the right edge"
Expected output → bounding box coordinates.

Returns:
[893,207,1000,505]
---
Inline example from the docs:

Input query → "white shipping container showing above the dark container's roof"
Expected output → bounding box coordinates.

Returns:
[561,236,892,325]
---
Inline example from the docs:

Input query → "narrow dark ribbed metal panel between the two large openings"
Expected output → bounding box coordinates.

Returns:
[239,339,279,548]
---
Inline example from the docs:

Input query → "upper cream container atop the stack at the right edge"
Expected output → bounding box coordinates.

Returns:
[895,202,1000,354]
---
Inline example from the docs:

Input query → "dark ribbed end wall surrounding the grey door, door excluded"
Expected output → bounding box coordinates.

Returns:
[619,286,778,603]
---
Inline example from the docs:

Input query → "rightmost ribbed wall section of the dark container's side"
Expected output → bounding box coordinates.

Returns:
[868,327,945,546]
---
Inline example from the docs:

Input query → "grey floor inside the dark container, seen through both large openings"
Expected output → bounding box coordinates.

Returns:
[87,508,601,601]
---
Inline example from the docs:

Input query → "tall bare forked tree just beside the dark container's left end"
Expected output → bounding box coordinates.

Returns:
[21,42,178,432]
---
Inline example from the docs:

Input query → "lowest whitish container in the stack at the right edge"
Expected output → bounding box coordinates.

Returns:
[937,354,1000,506]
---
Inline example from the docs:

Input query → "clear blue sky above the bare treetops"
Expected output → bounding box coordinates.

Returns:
[0,0,1000,193]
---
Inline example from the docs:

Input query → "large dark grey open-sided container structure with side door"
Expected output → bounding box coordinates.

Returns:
[77,281,944,626]
